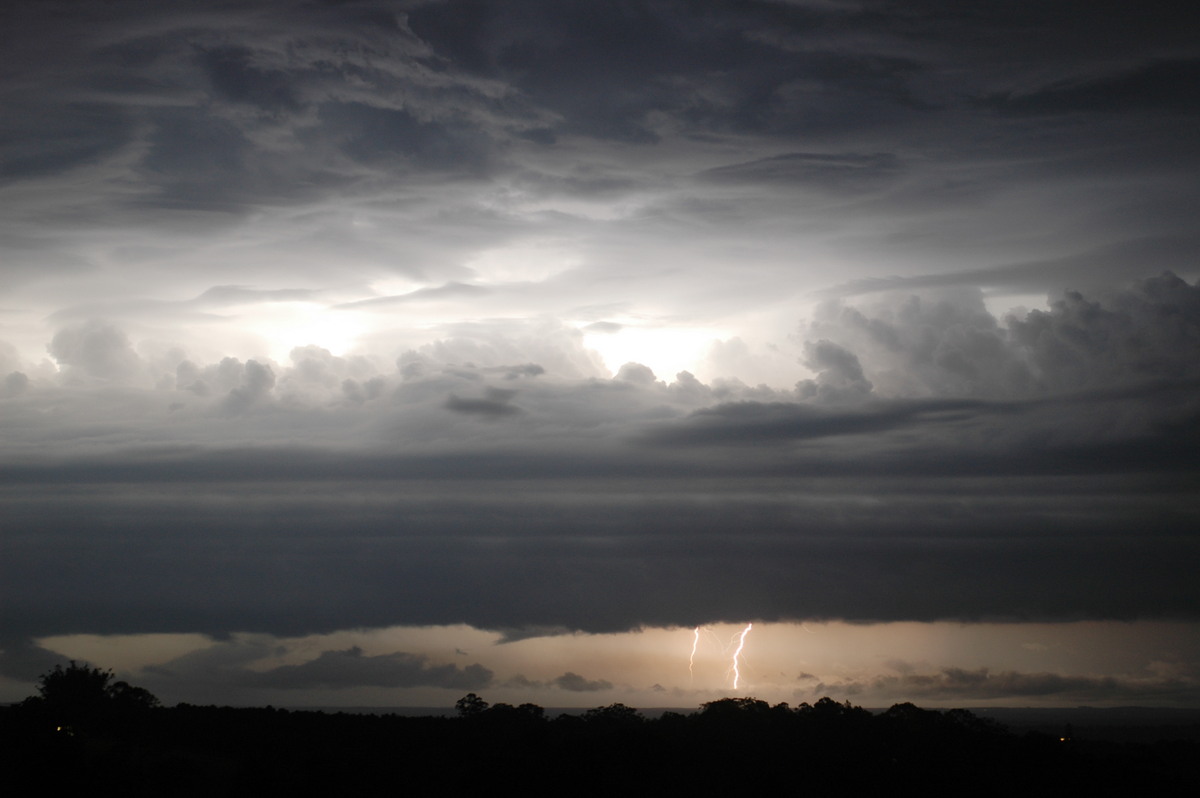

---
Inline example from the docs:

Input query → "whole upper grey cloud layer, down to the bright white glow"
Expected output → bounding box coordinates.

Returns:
[0,1,1198,312]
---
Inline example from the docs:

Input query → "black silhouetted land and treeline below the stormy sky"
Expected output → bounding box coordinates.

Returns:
[0,698,1200,796]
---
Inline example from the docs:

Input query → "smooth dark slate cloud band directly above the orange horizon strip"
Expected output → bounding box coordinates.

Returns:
[4,472,1200,635]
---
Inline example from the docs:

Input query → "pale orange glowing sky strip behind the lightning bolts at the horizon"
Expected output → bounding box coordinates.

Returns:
[21,622,1198,708]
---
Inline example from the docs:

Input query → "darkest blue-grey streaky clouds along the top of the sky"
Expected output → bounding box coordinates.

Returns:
[2,1,1195,182]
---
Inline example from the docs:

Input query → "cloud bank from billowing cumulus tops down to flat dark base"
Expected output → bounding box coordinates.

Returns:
[2,275,1200,635]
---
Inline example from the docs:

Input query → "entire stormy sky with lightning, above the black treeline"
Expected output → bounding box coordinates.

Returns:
[0,0,1200,707]
